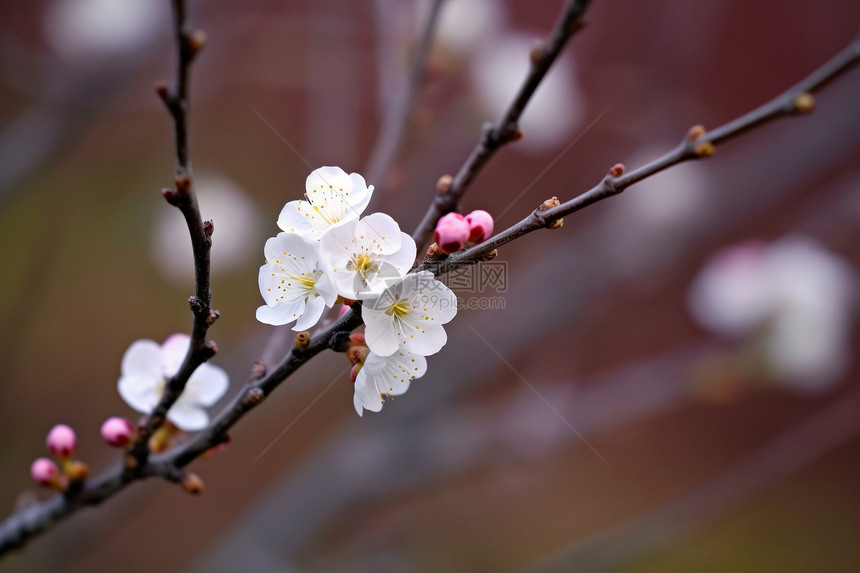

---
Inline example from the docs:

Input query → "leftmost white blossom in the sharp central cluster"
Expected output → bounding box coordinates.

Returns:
[257,233,337,331]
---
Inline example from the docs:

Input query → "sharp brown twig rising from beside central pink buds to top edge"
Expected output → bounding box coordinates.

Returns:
[412,0,591,248]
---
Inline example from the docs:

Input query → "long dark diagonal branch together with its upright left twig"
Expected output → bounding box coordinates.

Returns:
[0,11,860,554]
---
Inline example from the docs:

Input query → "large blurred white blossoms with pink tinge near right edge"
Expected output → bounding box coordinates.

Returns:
[689,237,857,390]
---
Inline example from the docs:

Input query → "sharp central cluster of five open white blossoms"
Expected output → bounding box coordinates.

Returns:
[257,167,470,415]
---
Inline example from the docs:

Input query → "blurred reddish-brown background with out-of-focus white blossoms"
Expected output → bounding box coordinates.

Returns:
[0,0,860,572]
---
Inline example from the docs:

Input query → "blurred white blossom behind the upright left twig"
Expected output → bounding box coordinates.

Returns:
[151,173,263,285]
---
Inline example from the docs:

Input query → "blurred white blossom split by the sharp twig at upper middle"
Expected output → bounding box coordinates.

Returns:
[470,34,585,153]
